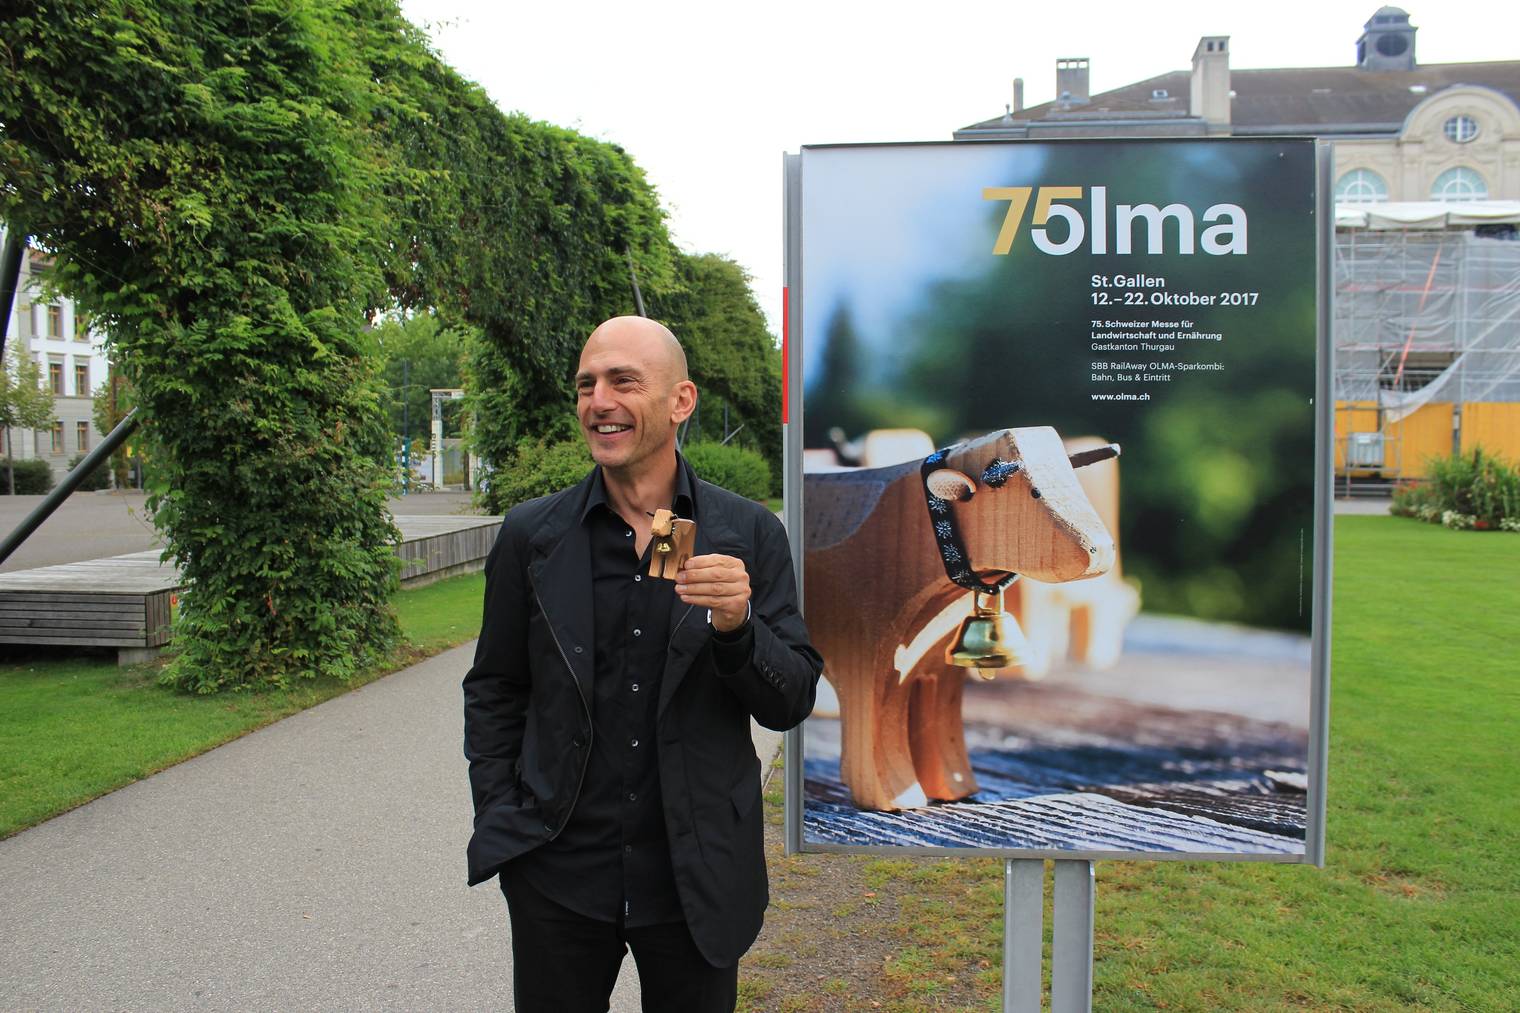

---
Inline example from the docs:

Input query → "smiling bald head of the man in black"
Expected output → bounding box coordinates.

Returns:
[575,316,696,475]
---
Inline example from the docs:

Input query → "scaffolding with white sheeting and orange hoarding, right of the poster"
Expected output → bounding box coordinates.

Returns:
[1332,230,1520,479]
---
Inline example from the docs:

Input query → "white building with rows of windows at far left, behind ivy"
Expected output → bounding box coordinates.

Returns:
[0,225,108,479]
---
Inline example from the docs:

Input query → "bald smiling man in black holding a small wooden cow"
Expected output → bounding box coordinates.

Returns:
[464,316,822,1013]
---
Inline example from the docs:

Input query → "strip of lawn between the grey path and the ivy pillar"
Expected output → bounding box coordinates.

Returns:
[0,573,485,838]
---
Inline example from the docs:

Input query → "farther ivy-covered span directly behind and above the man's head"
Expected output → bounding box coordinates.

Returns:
[357,37,675,510]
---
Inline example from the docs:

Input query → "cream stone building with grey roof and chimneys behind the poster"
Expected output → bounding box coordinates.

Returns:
[955,8,1520,211]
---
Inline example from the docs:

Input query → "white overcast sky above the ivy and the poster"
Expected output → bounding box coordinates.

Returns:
[401,0,1520,335]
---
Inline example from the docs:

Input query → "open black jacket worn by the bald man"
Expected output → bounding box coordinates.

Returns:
[464,459,822,966]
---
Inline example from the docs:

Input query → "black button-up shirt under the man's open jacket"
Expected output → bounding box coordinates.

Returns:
[512,467,754,928]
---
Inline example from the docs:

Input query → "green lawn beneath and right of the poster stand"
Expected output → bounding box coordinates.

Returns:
[742,517,1520,1013]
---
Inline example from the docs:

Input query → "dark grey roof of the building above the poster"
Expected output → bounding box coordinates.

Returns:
[956,59,1520,135]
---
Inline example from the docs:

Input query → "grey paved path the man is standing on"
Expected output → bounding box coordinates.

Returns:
[0,643,778,1011]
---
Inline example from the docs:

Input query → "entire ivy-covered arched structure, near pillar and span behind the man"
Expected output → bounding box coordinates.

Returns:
[0,0,784,681]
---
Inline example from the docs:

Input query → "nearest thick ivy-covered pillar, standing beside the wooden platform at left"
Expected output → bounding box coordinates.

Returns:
[0,0,395,692]
